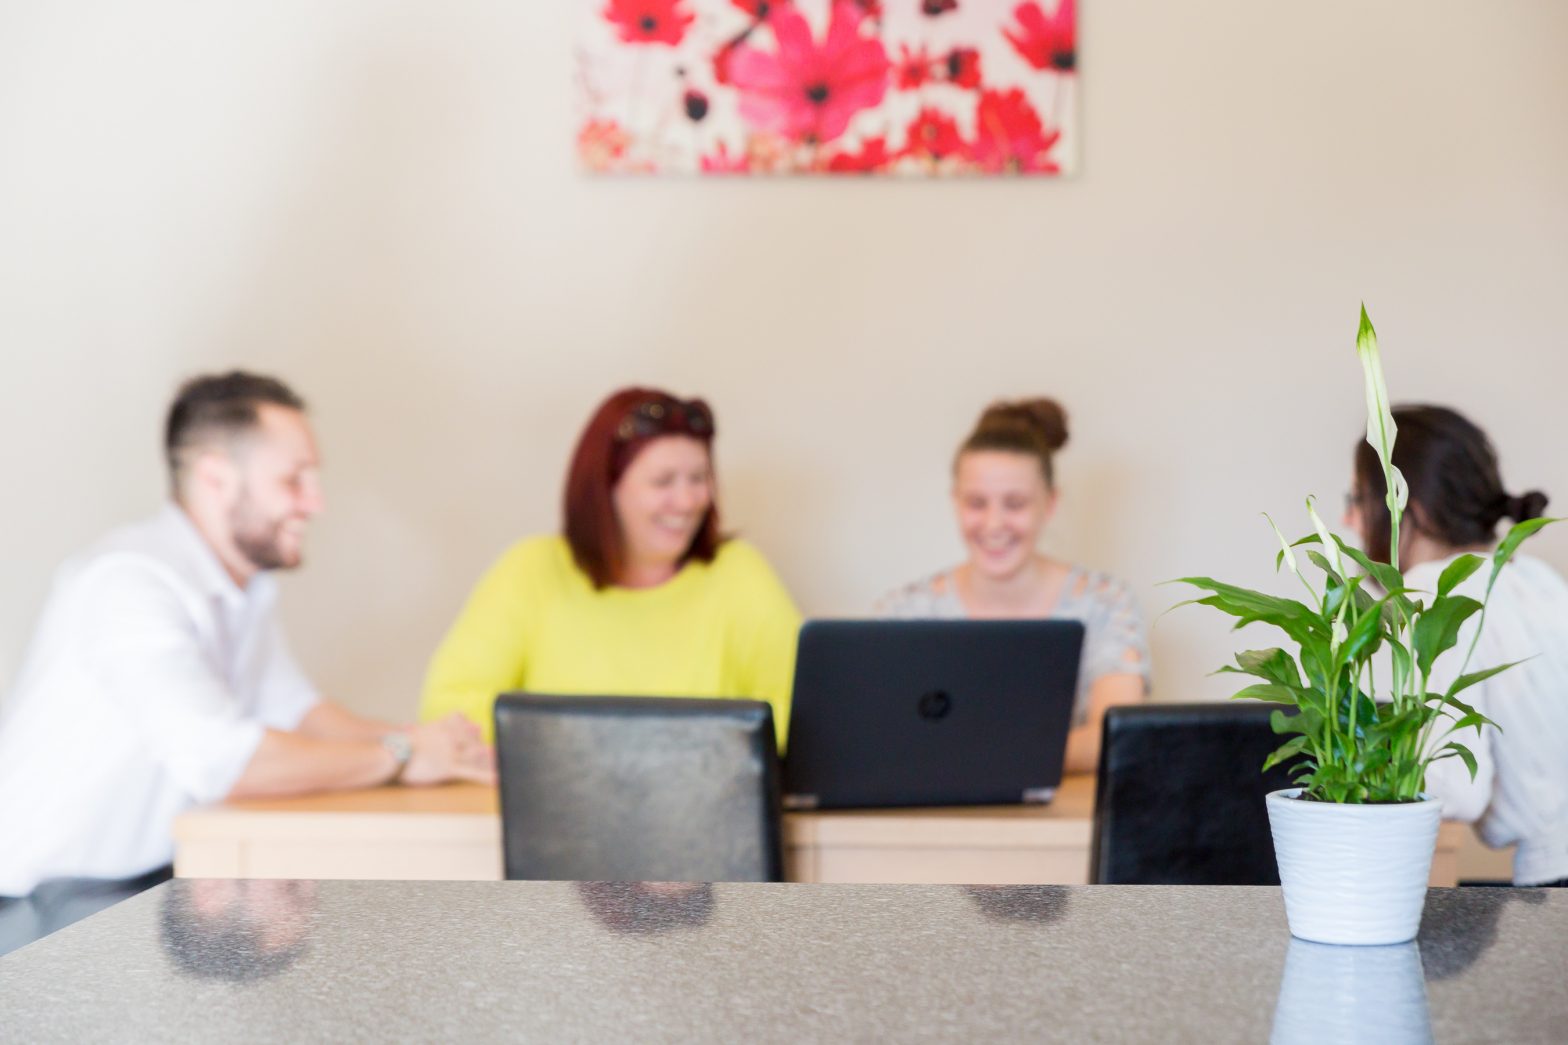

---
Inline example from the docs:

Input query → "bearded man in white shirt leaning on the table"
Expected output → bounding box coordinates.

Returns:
[0,372,494,952]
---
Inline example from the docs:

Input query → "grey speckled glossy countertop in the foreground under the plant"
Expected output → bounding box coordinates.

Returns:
[0,880,1568,1045]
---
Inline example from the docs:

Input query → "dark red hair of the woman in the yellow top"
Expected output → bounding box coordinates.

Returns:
[561,388,723,588]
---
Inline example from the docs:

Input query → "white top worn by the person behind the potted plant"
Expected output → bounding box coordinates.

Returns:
[1405,555,1568,885]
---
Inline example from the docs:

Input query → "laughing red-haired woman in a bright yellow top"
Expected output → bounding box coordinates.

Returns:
[420,388,800,742]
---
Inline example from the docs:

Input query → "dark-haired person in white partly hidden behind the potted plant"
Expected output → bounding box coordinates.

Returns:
[1345,406,1568,885]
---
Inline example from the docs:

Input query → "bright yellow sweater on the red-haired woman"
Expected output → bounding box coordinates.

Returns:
[420,537,800,745]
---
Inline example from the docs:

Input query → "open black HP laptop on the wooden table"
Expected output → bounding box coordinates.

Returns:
[784,620,1083,810]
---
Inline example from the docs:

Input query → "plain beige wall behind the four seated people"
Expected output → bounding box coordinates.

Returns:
[0,0,1568,715]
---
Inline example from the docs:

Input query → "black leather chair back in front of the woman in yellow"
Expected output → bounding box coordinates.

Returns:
[495,694,782,882]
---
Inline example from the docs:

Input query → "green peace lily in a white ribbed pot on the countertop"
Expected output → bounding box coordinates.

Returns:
[1181,306,1551,943]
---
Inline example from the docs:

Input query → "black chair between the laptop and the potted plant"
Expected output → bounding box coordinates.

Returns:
[1090,700,1294,885]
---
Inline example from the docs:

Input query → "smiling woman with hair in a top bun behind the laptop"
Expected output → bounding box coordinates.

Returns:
[875,399,1149,772]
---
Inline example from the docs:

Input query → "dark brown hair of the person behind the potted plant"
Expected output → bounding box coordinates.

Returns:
[1355,406,1546,562]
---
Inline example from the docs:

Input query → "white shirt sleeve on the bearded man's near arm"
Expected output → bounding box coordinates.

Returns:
[78,557,265,802]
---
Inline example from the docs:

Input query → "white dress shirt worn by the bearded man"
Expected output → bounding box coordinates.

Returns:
[0,505,318,896]
